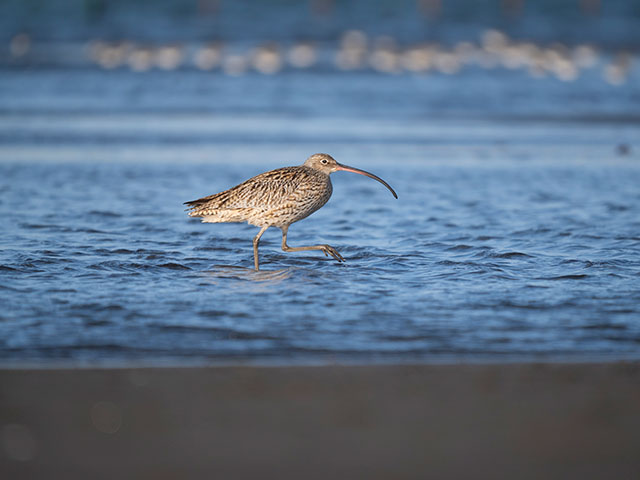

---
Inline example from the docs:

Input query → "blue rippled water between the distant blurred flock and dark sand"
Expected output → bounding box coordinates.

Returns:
[0,71,640,365]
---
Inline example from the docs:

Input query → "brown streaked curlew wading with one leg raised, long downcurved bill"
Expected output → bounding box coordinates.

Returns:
[185,153,398,270]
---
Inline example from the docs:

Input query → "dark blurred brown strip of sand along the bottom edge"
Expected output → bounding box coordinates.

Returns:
[0,363,640,479]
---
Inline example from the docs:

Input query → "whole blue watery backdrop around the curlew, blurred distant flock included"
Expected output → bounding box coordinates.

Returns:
[0,0,640,362]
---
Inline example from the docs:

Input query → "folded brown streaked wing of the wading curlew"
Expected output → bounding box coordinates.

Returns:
[185,167,308,216]
